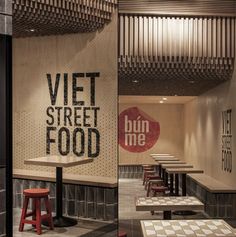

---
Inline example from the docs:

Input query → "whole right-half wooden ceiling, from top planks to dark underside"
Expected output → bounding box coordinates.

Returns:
[119,0,236,96]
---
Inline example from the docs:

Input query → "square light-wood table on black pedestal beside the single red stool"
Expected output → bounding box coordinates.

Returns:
[24,155,94,227]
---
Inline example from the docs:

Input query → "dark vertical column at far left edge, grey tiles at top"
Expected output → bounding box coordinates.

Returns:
[0,0,13,237]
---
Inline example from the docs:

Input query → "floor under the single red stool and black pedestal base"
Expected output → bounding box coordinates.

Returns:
[13,209,117,237]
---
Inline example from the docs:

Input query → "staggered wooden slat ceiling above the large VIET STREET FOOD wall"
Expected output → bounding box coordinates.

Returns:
[13,0,117,37]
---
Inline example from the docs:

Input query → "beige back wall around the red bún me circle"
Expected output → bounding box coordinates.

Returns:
[119,104,184,164]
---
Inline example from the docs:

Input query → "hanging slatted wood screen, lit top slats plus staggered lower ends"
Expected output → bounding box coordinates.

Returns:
[119,14,236,94]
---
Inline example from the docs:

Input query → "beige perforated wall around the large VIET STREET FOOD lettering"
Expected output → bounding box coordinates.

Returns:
[13,15,117,177]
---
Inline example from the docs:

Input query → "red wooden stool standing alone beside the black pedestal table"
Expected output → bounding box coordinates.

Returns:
[19,188,54,235]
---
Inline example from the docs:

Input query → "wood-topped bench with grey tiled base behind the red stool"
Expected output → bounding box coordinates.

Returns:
[13,169,118,222]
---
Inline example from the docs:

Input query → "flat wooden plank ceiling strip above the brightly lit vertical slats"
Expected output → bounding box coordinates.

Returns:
[119,0,236,16]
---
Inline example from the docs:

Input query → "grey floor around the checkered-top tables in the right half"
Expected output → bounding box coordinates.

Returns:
[119,179,212,237]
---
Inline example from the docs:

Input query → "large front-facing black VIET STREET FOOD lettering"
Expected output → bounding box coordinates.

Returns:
[46,73,100,157]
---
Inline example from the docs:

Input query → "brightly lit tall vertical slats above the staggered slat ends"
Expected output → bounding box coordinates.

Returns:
[119,15,235,59]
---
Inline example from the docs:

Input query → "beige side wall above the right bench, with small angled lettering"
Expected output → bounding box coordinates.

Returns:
[184,60,236,188]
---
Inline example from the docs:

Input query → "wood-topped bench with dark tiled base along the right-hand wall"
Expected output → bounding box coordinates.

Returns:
[187,174,236,219]
